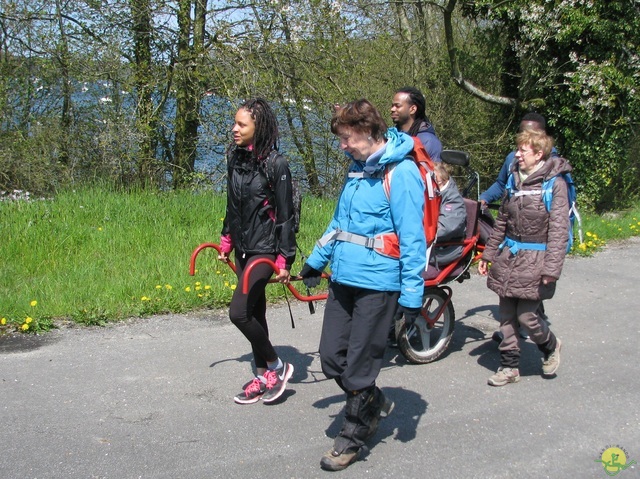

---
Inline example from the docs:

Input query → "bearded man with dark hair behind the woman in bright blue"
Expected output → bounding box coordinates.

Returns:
[391,87,442,162]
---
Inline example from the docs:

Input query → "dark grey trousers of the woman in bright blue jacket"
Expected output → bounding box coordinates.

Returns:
[320,282,400,391]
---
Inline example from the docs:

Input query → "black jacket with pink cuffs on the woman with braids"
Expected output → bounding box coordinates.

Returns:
[222,146,296,269]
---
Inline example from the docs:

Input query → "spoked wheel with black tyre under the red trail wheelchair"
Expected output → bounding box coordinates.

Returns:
[395,287,455,364]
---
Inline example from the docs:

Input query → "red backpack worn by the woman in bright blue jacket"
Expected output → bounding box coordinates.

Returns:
[382,136,442,247]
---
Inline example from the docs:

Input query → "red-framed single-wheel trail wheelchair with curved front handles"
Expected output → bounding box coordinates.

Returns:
[189,150,480,364]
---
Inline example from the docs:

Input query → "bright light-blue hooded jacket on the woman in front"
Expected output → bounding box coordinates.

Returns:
[307,128,427,308]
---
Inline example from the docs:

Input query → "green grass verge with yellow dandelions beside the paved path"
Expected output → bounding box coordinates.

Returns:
[0,187,640,332]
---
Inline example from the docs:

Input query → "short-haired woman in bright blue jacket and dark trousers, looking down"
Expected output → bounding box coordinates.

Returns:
[300,99,426,470]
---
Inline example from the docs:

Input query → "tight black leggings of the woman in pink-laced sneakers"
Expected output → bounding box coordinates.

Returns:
[229,254,278,368]
